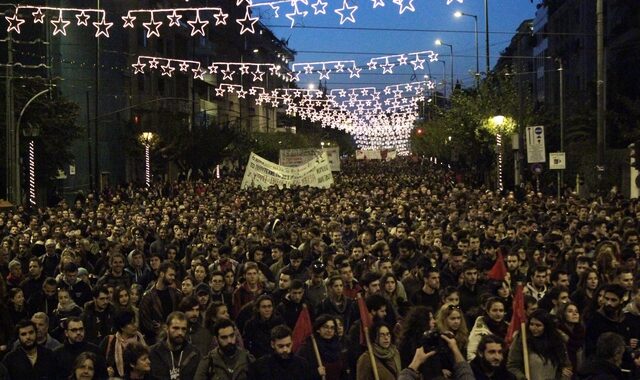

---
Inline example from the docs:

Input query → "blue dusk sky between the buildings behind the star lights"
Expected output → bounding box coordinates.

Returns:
[254,0,538,88]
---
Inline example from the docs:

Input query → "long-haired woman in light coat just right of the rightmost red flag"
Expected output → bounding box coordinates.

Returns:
[507,309,573,380]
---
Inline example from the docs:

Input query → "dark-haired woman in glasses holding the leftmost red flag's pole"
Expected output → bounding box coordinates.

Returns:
[298,314,347,380]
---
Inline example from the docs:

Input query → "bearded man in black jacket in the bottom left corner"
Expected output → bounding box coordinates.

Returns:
[2,319,56,380]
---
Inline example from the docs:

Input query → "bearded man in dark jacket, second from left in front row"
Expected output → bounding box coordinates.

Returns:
[53,317,108,380]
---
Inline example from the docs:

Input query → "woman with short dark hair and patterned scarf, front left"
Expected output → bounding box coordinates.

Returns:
[100,310,147,377]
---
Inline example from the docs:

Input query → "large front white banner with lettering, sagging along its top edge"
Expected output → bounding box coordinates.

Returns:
[240,153,333,190]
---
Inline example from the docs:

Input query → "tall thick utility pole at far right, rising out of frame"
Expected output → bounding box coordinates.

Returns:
[596,0,606,186]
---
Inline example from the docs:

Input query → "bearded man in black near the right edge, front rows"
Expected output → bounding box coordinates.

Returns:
[585,284,636,357]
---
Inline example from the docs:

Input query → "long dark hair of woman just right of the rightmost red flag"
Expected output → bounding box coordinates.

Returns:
[527,309,567,366]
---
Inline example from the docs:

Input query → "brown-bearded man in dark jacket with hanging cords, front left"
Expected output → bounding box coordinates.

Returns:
[149,311,200,380]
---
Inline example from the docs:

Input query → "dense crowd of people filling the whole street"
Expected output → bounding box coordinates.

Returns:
[0,159,640,380]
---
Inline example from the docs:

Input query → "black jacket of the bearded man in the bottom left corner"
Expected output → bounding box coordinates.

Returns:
[2,346,56,380]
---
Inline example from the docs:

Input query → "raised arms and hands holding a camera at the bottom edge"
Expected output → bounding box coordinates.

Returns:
[398,333,476,380]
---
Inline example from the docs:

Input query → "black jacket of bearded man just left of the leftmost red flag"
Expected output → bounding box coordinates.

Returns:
[247,354,314,380]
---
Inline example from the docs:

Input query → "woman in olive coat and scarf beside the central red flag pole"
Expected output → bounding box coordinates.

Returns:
[356,322,402,380]
